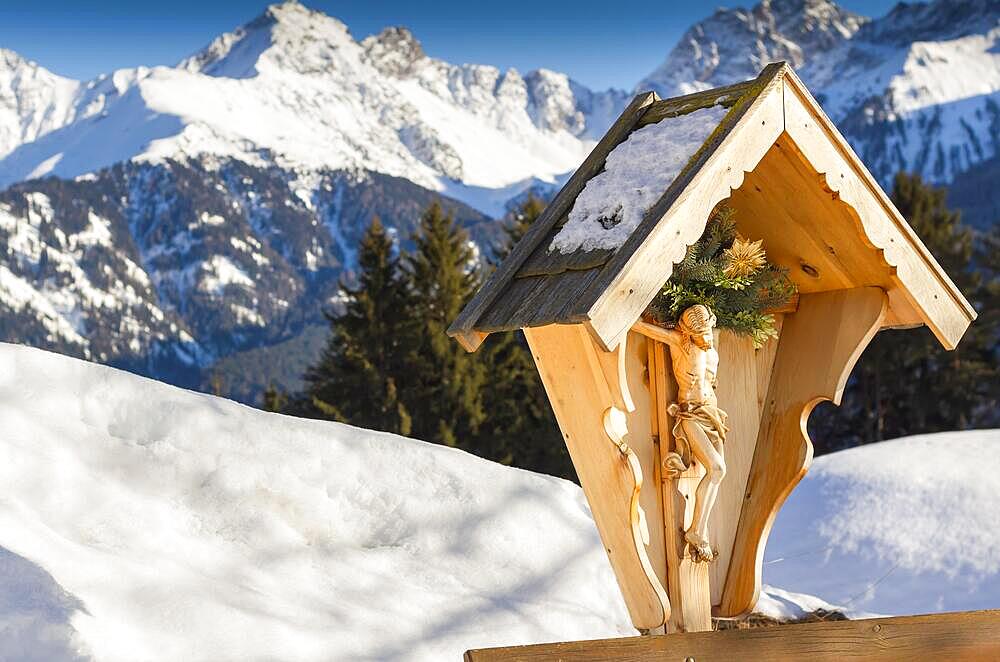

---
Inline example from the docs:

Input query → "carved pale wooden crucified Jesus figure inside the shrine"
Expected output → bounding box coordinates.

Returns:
[664,305,728,561]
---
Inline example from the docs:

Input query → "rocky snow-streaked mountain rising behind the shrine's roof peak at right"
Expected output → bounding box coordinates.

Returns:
[638,0,1000,225]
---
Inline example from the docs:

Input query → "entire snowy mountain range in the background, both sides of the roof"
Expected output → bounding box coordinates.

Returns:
[0,0,1000,400]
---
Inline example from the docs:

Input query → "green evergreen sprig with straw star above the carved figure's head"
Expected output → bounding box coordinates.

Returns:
[646,205,796,347]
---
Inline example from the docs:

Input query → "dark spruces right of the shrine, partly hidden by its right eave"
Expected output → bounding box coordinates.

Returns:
[810,173,998,453]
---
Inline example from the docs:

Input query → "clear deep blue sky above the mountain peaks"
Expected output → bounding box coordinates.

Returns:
[0,0,895,89]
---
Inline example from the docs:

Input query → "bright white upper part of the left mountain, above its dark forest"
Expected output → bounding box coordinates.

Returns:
[0,2,625,215]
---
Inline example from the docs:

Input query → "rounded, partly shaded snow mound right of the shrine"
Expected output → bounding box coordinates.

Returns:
[764,430,1000,615]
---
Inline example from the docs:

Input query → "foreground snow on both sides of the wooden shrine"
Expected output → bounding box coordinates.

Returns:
[0,344,1000,662]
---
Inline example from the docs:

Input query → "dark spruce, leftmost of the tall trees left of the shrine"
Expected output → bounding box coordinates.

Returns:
[301,217,415,435]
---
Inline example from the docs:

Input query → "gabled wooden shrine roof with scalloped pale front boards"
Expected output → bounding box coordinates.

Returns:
[448,62,975,351]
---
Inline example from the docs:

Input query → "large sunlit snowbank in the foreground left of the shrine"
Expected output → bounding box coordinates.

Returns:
[0,345,634,662]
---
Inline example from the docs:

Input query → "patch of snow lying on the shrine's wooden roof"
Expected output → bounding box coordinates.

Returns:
[549,106,728,253]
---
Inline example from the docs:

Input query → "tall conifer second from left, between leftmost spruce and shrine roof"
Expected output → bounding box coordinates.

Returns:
[404,202,486,454]
